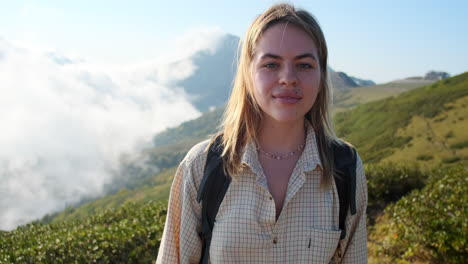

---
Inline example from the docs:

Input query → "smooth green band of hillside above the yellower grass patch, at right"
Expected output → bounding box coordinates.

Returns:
[335,73,468,163]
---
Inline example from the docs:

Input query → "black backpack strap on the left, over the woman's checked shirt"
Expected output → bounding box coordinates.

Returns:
[197,136,231,264]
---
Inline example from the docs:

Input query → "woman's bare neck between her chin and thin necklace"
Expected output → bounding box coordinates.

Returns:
[258,119,306,153]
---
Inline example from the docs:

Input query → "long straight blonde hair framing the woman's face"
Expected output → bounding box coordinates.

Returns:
[218,4,336,186]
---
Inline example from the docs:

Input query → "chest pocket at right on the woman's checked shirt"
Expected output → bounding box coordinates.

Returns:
[293,228,341,263]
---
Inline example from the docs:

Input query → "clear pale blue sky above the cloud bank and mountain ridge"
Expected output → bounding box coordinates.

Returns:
[0,0,468,83]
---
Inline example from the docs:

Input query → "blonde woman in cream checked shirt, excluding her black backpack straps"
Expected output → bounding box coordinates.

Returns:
[157,4,367,263]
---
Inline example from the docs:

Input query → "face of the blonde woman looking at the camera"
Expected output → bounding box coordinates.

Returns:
[251,23,320,126]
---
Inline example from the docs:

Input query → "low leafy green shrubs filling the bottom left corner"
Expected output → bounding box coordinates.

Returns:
[0,202,166,264]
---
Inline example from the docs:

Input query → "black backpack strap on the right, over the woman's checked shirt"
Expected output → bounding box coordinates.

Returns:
[332,141,357,239]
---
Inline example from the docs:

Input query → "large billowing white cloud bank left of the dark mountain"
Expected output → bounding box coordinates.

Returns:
[0,27,225,230]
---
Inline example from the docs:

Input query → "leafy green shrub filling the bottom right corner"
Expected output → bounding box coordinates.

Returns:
[381,166,468,263]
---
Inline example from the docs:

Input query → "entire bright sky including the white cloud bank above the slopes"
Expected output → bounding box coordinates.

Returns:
[0,0,468,230]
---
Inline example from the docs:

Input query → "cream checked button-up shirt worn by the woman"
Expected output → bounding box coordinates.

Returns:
[156,125,367,264]
